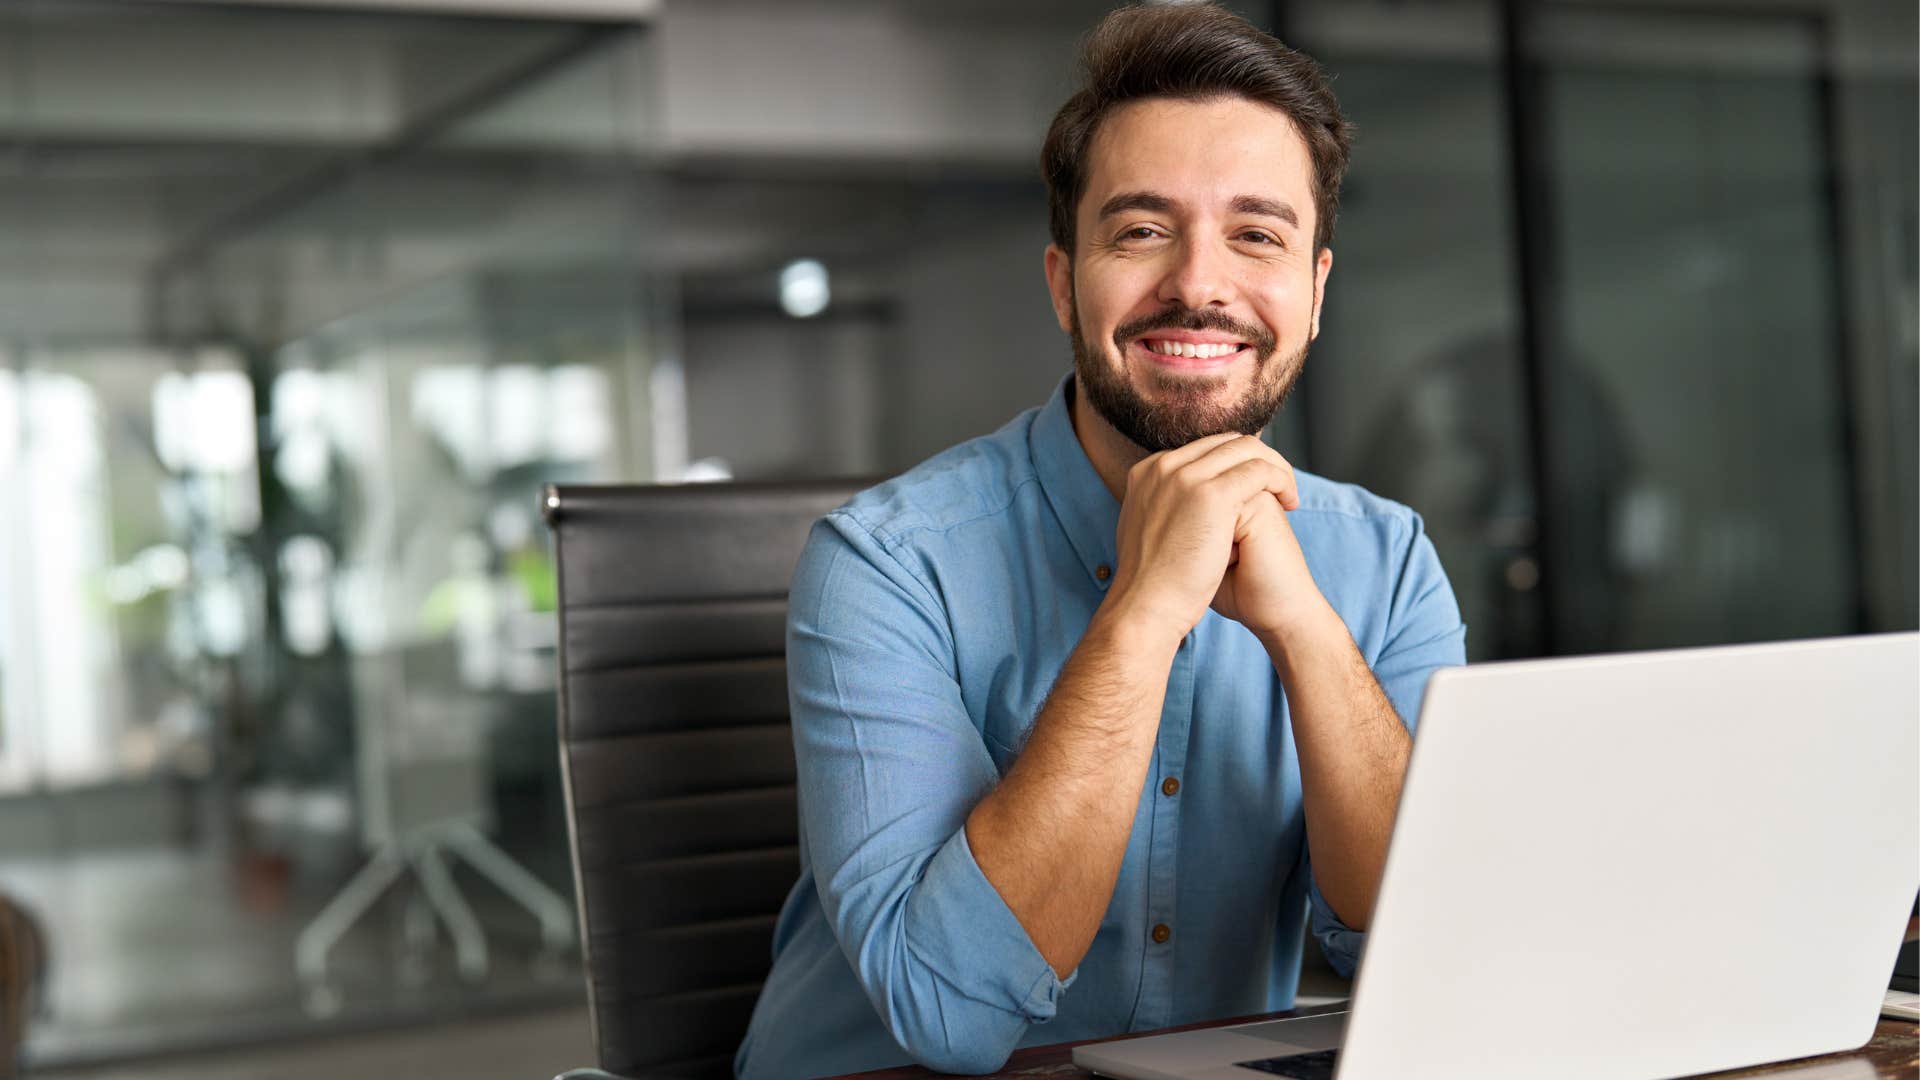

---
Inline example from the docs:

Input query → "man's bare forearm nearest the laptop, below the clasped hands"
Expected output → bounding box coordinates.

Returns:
[1265,607,1413,930]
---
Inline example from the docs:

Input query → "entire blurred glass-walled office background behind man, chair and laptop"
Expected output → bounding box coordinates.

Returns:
[0,0,1920,1076]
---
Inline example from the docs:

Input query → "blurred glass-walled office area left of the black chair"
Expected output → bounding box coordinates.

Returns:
[0,0,660,1063]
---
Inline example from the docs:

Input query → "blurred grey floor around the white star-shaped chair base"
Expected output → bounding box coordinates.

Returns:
[0,849,588,1076]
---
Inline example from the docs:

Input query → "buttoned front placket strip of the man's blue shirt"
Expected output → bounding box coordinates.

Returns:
[1133,634,1196,1030]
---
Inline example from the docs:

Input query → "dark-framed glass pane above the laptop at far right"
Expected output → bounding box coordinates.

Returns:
[1534,10,1859,651]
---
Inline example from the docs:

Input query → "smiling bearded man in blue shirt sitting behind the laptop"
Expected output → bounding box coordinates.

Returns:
[735,6,1465,1078]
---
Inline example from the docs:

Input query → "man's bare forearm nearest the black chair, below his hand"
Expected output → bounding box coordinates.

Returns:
[966,609,1179,978]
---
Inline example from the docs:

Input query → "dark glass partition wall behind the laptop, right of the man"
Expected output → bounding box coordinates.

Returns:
[1273,0,1920,659]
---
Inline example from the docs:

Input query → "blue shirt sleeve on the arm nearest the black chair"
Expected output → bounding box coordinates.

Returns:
[787,511,1071,1072]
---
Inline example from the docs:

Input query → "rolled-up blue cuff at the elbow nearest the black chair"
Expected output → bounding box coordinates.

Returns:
[908,826,1079,1024]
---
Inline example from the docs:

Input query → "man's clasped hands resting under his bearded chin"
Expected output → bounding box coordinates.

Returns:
[1102,434,1297,638]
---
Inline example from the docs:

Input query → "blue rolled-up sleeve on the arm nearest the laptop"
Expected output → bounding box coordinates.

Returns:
[1300,513,1467,978]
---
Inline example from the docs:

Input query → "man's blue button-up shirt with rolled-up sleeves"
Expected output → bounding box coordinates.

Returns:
[735,379,1465,1078]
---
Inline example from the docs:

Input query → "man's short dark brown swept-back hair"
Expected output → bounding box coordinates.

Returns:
[1041,4,1352,256]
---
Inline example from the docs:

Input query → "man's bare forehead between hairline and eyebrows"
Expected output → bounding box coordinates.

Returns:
[1083,98,1313,213]
